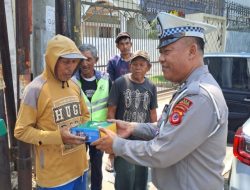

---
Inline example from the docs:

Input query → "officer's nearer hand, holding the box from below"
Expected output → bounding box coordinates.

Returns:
[91,128,117,154]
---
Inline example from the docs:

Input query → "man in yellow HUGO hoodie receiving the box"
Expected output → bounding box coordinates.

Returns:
[14,35,89,190]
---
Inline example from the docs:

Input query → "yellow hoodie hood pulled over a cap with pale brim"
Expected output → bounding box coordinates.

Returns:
[44,34,86,80]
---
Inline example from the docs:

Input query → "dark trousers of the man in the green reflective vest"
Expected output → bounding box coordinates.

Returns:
[87,144,103,190]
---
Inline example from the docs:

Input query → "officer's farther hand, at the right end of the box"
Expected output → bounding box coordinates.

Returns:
[108,119,135,138]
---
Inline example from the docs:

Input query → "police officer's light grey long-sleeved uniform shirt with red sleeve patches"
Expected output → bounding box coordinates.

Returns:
[113,66,228,190]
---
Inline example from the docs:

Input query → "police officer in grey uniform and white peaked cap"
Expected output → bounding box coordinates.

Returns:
[93,13,228,190]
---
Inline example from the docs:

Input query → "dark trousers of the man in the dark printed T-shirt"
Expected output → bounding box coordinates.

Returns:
[114,157,148,190]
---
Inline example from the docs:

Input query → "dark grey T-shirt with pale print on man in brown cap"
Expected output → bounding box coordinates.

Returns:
[108,74,158,123]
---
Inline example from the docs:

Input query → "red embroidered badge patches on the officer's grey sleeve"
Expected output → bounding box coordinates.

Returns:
[169,98,193,125]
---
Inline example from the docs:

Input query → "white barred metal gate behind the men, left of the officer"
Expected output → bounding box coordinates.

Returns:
[81,0,170,92]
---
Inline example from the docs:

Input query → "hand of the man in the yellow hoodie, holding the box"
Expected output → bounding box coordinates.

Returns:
[60,127,85,145]
